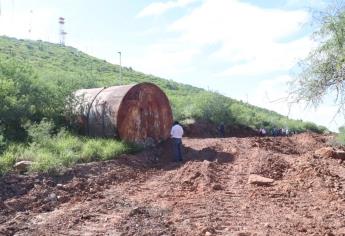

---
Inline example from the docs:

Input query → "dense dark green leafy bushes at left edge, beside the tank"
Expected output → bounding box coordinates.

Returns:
[0,60,69,141]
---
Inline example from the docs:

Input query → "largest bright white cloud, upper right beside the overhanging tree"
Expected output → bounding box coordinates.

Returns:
[170,0,313,76]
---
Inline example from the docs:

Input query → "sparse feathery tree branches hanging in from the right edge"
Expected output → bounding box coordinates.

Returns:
[291,3,345,111]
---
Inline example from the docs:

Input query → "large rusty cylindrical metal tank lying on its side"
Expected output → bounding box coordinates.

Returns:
[75,83,173,142]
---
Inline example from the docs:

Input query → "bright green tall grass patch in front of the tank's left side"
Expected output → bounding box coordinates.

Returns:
[0,131,139,175]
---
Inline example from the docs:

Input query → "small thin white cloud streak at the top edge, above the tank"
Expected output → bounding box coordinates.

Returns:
[137,0,197,17]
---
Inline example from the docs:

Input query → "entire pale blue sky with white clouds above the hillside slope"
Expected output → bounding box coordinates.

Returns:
[0,0,343,130]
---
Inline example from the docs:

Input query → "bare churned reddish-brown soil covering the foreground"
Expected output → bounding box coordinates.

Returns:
[0,134,345,235]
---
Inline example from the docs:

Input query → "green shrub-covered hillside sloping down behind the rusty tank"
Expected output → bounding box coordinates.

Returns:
[0,37,325,135]
